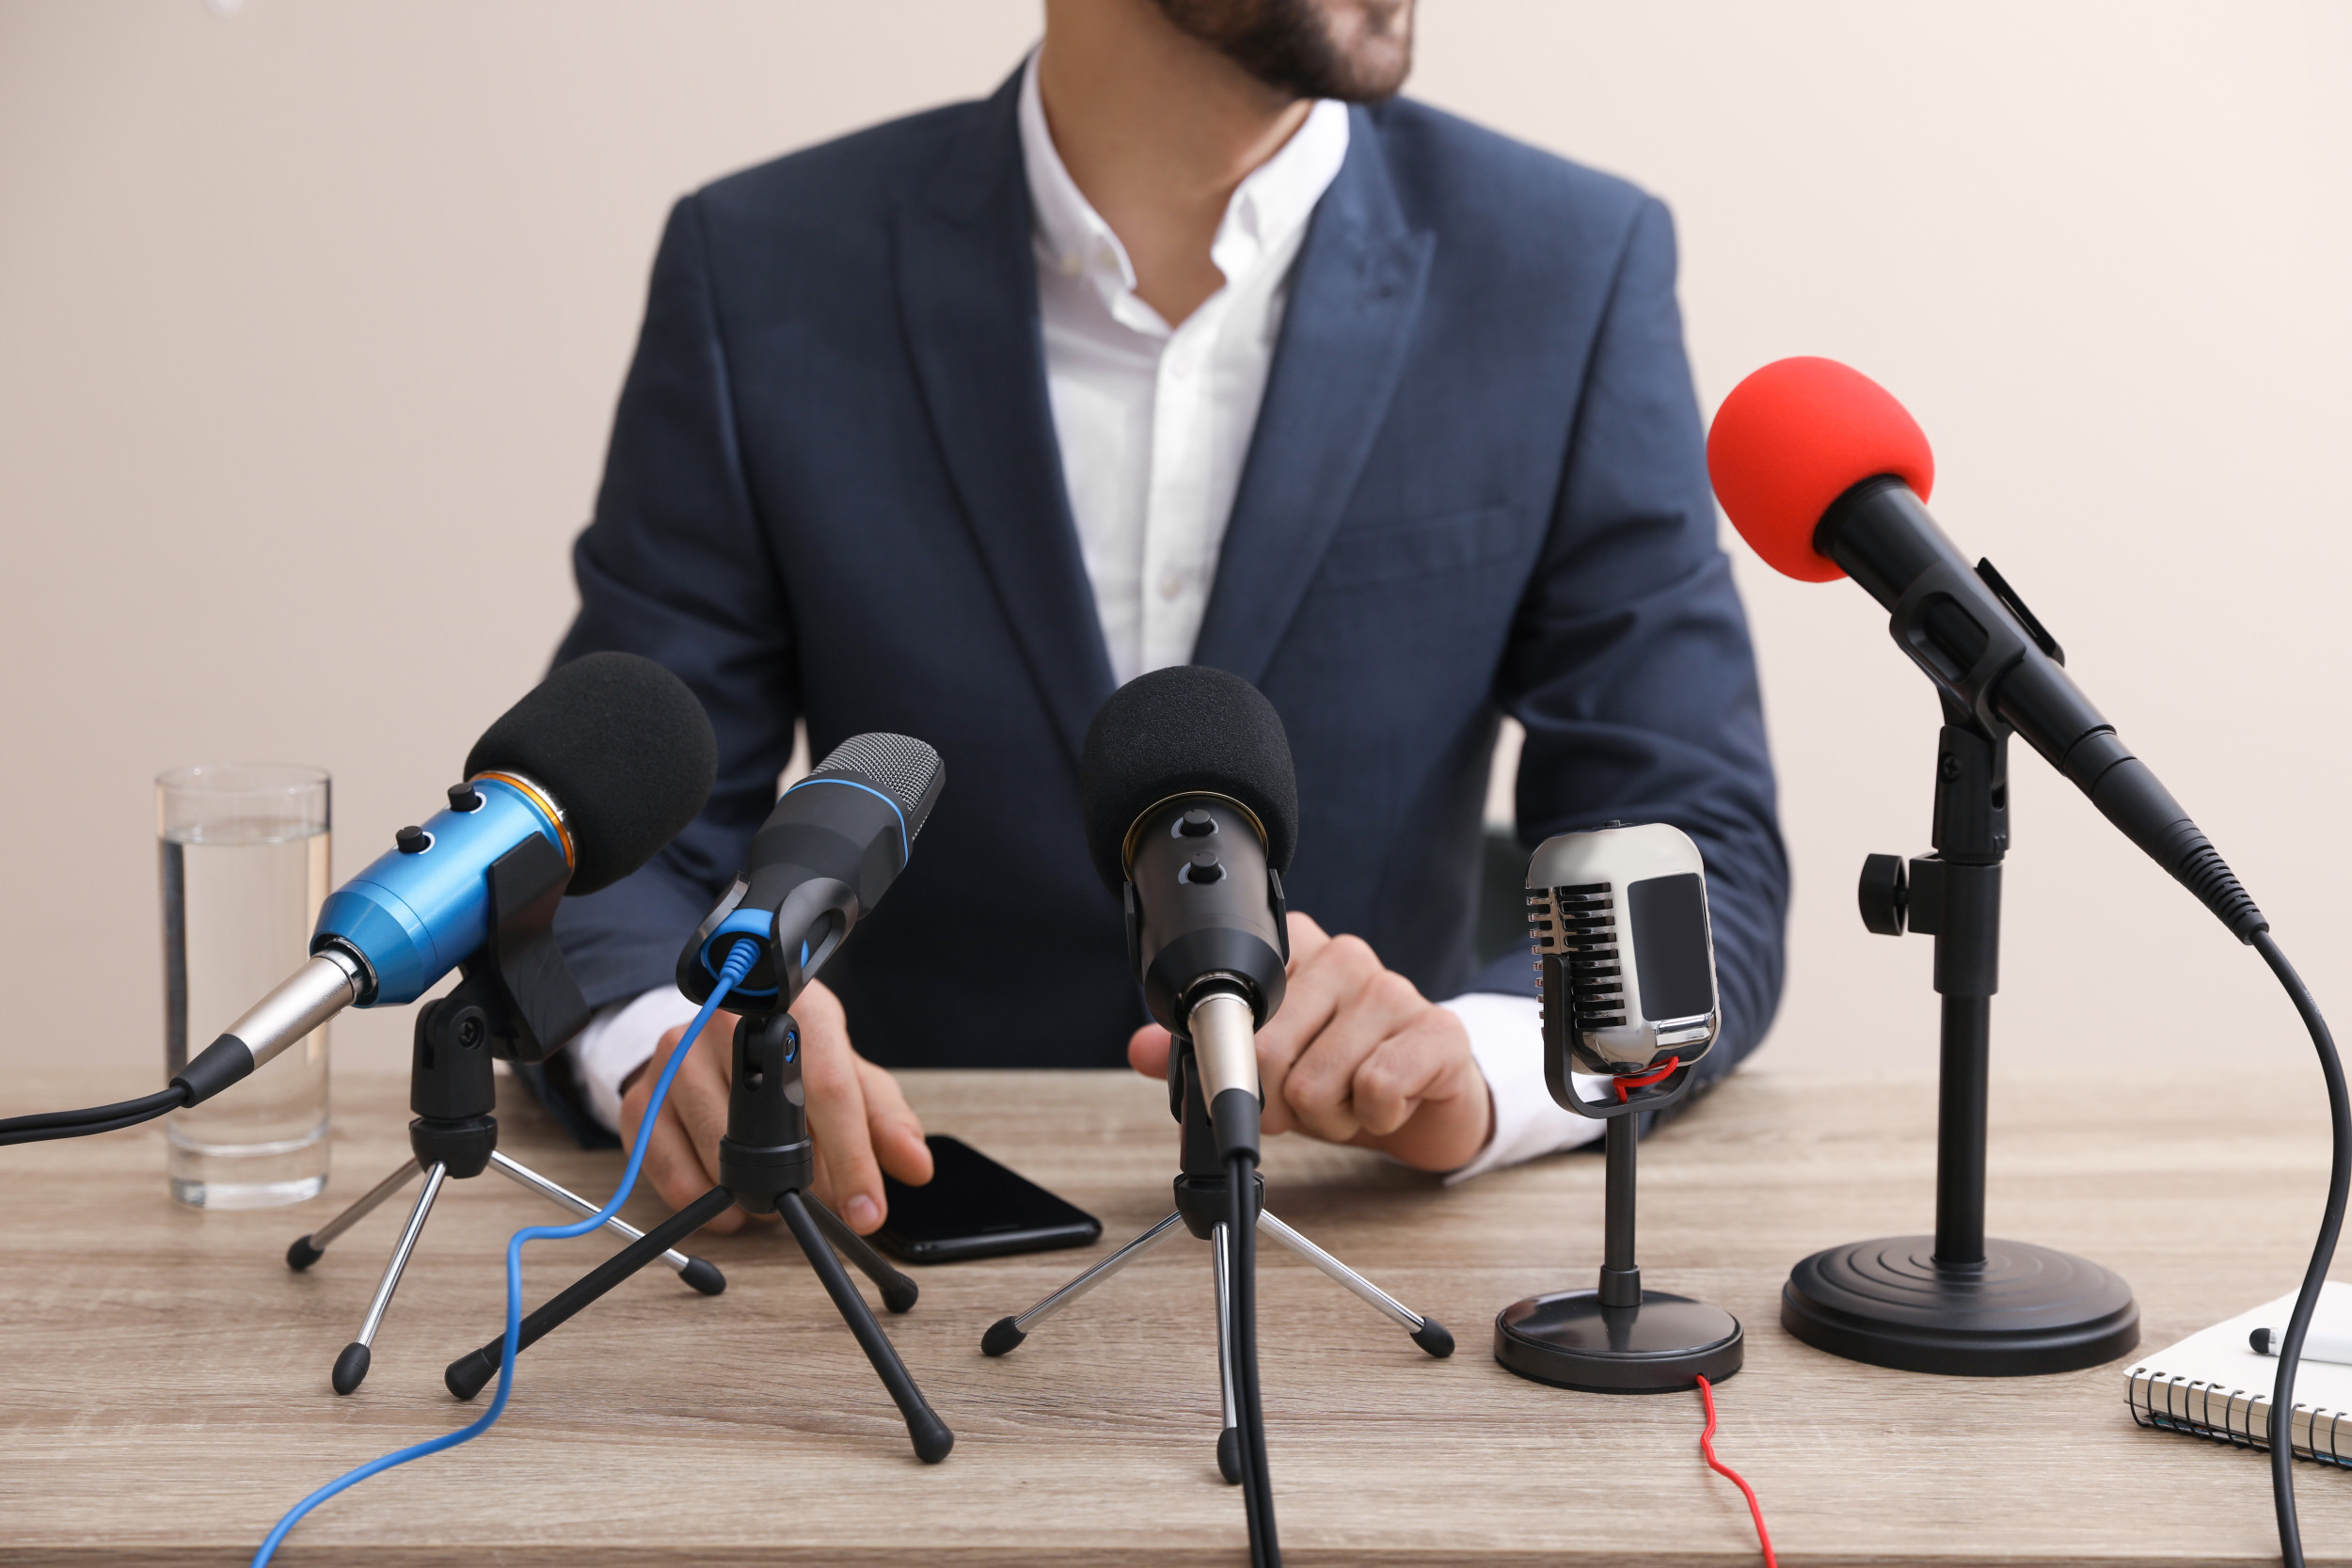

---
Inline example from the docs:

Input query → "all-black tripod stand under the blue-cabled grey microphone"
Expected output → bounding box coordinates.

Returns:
[442,1013,955,1465]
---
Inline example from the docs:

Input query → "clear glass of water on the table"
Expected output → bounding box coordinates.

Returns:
[155,764,327,1209]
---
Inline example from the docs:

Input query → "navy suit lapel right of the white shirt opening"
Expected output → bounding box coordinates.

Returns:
[1193,108,1435,682]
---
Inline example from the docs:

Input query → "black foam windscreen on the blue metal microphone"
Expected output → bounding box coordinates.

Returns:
[466,654,720,895]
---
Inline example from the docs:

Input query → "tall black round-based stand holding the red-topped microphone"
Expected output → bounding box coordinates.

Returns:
[1781,701,2140,1378]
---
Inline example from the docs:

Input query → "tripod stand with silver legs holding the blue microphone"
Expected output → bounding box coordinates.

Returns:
[287,832,727,1394]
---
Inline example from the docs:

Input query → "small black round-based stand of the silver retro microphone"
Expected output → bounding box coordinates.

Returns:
[1494,1068,1748,1394]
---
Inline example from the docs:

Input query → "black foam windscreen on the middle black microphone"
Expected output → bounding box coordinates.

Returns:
[1077,665,1298,889]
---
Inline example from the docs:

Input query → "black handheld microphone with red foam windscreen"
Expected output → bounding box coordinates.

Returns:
[1708,357,2270,942]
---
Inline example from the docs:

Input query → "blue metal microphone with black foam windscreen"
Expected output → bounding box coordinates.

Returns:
[172,654,718,1105]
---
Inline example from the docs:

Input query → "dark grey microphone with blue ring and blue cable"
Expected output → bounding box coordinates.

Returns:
[677,734,948,1018]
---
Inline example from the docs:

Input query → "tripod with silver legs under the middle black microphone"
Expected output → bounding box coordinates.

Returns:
[981,1037,1454,1486]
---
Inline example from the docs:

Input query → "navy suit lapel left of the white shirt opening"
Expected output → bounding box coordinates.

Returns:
[894,72,1113,762]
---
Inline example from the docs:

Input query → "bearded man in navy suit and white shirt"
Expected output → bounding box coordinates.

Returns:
[541,0,1788,1232]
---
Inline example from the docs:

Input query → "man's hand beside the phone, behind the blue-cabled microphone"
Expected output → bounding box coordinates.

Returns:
[621,980,931,1234]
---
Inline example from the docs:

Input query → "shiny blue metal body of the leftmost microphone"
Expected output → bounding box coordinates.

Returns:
[310,773,574,1006]
